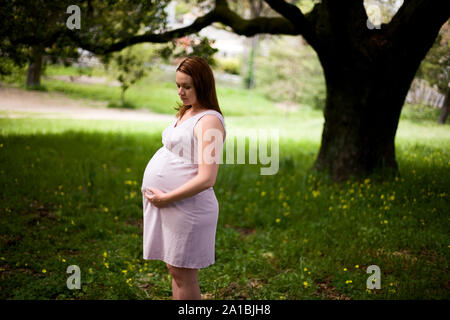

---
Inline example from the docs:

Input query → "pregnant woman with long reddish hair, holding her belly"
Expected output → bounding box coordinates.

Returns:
[141,57,226,299]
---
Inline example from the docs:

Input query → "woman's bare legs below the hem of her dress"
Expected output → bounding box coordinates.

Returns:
[166,264,201,300]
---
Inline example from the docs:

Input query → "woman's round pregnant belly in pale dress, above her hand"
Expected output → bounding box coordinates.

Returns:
[141,146,198,192]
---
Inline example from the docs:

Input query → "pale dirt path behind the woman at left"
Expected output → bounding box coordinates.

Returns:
[0,87,175,121]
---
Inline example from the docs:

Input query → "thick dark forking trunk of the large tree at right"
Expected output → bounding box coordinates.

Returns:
[310,1,446,181]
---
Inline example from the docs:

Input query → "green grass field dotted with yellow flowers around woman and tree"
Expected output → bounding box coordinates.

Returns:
[0,67,450,299]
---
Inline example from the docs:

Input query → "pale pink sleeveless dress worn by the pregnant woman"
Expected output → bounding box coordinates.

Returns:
[141,110,226,269]
